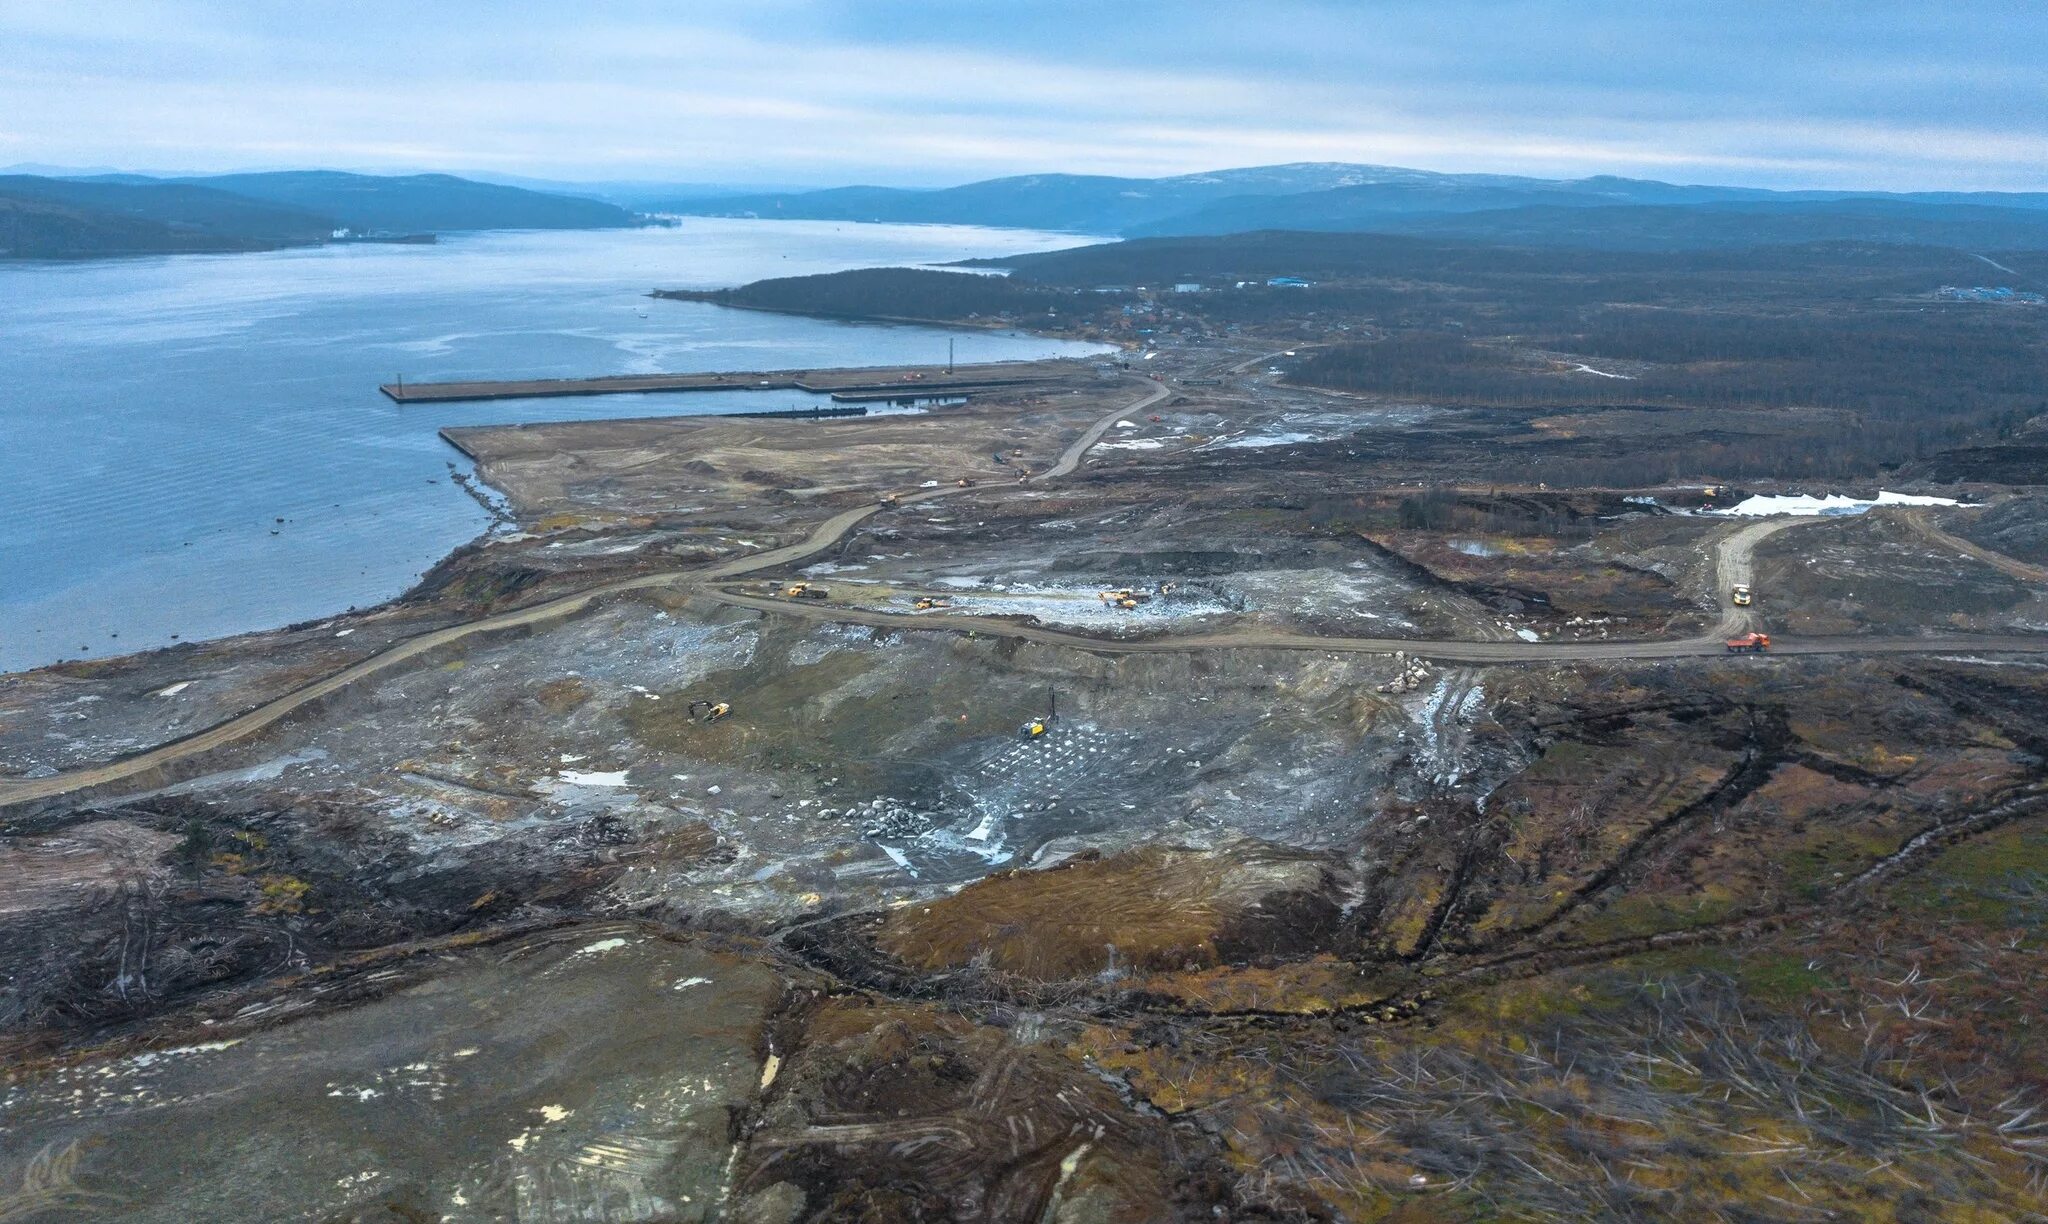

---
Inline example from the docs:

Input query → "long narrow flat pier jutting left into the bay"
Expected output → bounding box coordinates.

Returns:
[379,362,1073,403]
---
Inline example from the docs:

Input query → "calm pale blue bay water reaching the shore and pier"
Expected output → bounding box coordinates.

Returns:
[0,219,1092,671]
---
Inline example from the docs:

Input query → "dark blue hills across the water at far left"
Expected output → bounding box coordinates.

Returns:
[0,170,643,260]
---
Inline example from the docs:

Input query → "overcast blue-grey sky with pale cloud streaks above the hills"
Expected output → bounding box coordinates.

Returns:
[0,0,2048,190]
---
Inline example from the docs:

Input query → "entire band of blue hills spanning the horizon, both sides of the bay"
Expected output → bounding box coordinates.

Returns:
[16,162,2048,258]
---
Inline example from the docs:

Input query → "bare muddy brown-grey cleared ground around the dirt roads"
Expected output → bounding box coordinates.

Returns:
[0,346,2048,1224]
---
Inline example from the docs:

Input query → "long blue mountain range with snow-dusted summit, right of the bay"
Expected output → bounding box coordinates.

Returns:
[649,162,2048,250]
